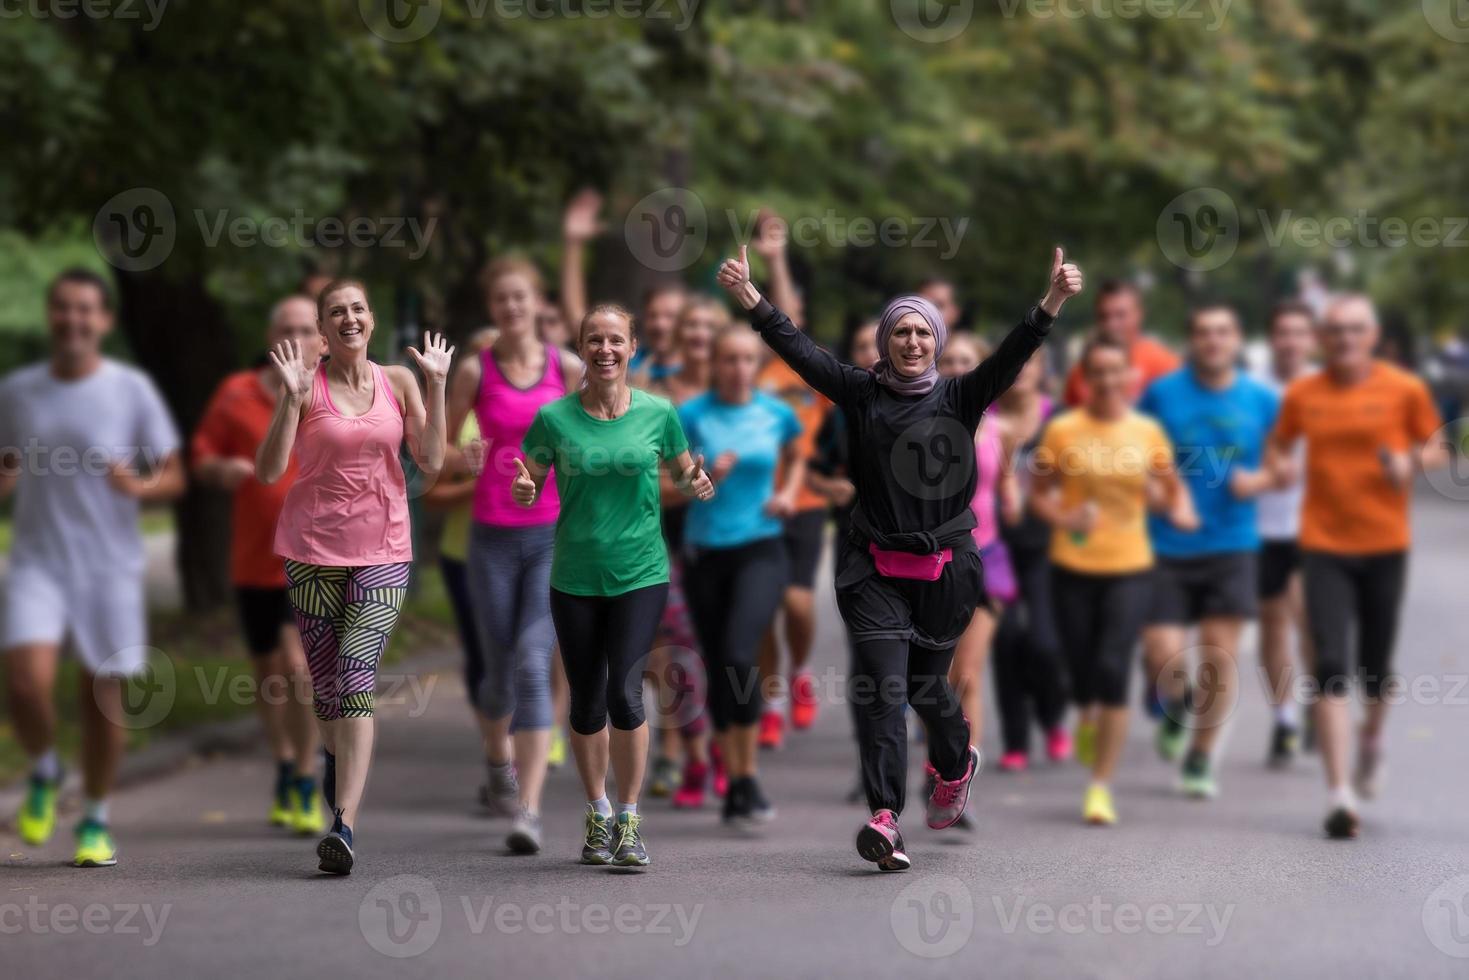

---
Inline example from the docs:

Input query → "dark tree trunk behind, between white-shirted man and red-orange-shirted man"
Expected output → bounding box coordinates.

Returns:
[118,270,235,613]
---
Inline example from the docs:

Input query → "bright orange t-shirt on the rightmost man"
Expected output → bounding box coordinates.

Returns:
[1271,361,1441,554]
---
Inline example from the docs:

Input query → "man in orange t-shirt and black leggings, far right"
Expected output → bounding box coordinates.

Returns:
[1268,295,1447,837]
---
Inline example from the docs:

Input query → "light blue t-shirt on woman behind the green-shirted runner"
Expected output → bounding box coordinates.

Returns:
[679,391,801,548]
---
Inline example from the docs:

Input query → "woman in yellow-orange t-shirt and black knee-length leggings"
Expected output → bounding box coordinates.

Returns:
[1030,339,1199,824]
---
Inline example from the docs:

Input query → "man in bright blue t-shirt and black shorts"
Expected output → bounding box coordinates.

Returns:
[1137,306,1279,798]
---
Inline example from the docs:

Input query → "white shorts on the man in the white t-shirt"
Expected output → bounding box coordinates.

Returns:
[0,564,148,677]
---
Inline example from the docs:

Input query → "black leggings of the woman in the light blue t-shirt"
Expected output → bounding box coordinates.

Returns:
[683,538,789,732]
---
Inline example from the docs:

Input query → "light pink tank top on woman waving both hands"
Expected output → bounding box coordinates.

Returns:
[275,364,413,567]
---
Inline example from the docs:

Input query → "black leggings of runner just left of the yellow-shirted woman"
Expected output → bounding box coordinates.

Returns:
[992,548,1066,752]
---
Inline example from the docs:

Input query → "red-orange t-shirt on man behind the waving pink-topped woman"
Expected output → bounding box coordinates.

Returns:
[191,370,297,589]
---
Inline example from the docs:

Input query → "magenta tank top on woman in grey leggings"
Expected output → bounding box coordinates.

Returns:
[474,347,566,527]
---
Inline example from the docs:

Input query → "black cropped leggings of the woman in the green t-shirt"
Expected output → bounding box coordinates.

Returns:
[551,582,668,735]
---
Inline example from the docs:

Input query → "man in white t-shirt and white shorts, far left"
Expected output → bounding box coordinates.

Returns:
[0,270,184,867]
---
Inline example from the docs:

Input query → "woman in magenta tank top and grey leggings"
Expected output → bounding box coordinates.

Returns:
[450,259,582,854]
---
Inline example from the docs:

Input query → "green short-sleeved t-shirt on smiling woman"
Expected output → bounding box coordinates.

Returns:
[520,388,689,595]
